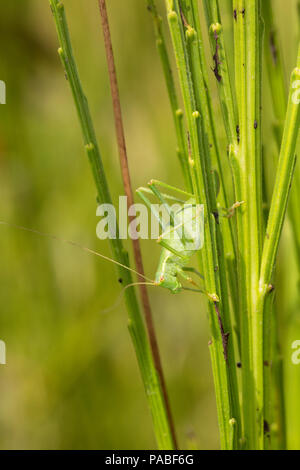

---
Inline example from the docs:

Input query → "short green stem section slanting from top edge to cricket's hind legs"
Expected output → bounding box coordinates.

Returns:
[146,0,192,191]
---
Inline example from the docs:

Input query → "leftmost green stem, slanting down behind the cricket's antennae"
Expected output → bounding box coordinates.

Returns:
[50,0,175,450]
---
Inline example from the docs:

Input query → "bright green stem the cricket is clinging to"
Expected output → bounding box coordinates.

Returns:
[166,0,239,449]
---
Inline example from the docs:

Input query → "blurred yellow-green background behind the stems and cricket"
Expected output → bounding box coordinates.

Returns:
[0,0,300,449]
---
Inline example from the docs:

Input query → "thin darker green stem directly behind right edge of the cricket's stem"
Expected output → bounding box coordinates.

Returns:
[182,0,241,446]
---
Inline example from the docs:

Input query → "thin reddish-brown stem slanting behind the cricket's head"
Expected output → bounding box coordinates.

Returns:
[98,0,178,448]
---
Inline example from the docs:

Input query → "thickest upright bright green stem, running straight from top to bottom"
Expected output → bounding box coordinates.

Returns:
[245,0,264,450]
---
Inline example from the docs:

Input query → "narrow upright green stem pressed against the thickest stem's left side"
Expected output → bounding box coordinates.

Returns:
[230,0,254,448]
